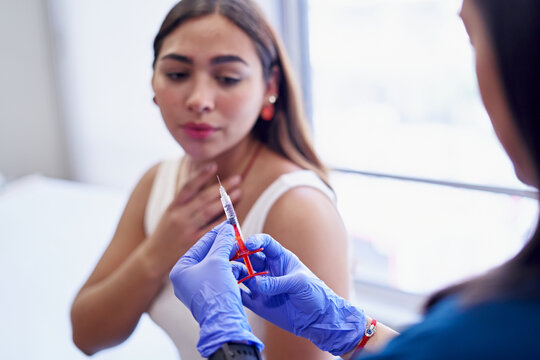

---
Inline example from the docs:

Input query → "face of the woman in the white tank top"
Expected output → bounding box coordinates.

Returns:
[152,14,275,160]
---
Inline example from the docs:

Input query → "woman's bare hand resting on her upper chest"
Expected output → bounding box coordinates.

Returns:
[145,163,240,276]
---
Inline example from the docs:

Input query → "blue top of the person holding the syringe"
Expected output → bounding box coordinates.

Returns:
[360,298,540,360]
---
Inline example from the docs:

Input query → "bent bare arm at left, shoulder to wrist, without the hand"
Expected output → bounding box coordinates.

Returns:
[71,167,162,355]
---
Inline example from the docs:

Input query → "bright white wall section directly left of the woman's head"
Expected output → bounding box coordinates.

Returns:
[49,0,181,187]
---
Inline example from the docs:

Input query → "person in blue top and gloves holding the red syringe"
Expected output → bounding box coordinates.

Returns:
[170,0,540,359]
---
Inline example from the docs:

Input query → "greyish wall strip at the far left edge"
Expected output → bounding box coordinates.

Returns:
[0,0,68,178]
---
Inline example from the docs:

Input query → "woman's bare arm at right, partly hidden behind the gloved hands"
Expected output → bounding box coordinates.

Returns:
[264,187,350,360]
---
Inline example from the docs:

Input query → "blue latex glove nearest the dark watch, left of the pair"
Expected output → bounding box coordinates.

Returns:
[169,223,264,358]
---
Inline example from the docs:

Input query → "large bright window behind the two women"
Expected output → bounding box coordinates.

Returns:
[307,0,537,294]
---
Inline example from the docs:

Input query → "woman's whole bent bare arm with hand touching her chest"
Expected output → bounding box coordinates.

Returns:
[71,167,243,355]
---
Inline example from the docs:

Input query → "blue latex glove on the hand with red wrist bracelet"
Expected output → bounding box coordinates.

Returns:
[233,234,366,356]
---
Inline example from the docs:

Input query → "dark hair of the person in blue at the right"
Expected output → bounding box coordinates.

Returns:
[426,0,540,309]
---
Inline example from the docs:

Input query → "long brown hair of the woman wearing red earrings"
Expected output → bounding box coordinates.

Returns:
[153,0,328,184]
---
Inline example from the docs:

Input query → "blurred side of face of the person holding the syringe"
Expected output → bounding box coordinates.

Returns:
[461,0,538,187]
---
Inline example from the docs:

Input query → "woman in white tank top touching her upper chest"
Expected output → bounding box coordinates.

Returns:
[71,0,349,359]
